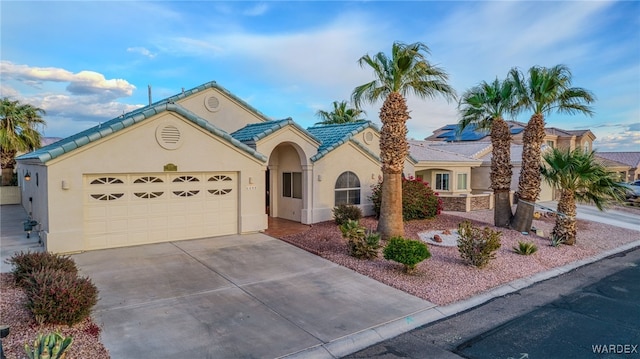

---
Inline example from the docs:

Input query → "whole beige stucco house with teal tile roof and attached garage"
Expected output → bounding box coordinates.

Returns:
[17,82,384,253]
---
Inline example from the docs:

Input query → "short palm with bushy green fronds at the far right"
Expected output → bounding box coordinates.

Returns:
[540,148,625,245]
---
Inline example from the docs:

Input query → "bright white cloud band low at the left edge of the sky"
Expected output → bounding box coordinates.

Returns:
[0,61,136,101]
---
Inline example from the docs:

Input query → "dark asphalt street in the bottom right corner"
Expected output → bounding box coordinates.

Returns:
[344,248,640,359]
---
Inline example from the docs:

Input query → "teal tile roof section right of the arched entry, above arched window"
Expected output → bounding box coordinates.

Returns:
[307,121,378,162]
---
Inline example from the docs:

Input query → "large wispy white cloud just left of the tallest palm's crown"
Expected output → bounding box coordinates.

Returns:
[166,14,387,88]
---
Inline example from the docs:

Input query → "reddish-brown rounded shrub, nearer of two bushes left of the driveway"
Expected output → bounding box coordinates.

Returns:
[24,268,98,326]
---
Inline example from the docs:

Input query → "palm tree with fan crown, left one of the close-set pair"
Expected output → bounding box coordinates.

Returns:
[458,79,515,228]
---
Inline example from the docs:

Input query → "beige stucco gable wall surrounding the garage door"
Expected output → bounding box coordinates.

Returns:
[38,113,267,252]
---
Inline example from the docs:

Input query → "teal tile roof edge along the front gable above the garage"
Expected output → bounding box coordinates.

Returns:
[16,101,267,163]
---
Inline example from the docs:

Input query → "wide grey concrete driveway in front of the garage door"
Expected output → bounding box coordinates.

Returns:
[73,234,434,358]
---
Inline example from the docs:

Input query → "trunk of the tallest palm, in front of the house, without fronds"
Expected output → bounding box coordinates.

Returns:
[378,92,410,239]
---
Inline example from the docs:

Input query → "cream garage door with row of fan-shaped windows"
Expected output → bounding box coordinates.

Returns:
[84,172,238,249]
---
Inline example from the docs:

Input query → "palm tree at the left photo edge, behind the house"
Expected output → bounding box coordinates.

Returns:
[0,97,45,186]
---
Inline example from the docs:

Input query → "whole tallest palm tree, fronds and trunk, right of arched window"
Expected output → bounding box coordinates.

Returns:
[351,42,456,239]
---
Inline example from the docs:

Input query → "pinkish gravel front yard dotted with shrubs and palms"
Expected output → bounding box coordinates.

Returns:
[283,211,640,305]
